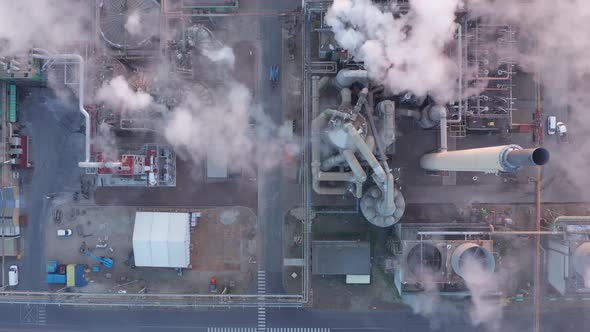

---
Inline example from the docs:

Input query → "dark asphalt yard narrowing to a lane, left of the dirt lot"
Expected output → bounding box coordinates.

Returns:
[18,88,84,290]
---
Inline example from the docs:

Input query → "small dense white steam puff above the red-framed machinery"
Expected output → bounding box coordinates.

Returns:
[96,76,153,111]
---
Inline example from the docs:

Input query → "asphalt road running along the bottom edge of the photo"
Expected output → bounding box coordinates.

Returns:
[0,304,590,332]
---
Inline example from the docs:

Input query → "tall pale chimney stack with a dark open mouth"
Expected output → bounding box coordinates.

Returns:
[420,144,549,173]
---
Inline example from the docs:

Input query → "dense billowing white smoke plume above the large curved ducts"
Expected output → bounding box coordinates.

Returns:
[326,0,460,102]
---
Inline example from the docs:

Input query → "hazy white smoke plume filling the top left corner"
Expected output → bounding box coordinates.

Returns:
[0,0,91,55]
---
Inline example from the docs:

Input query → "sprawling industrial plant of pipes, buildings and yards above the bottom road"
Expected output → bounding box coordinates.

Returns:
[0,0,590,331]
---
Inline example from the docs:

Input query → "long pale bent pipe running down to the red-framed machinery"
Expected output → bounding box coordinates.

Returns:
[32,48,122,168]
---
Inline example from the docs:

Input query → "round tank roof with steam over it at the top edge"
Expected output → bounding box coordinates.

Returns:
[99,0,160,49]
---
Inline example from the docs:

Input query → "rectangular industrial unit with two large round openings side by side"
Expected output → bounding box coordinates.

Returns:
[390,223,496,297]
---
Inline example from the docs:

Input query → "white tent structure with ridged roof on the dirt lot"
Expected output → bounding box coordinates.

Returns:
[133,212,190,268]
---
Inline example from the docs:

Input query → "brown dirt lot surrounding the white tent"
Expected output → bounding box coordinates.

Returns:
[46,199,258,294]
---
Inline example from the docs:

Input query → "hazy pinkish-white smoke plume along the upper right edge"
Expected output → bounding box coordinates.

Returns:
[468,0,590,195]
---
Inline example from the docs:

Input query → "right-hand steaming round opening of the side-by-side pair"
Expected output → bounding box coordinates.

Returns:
[451,242,496,283]
